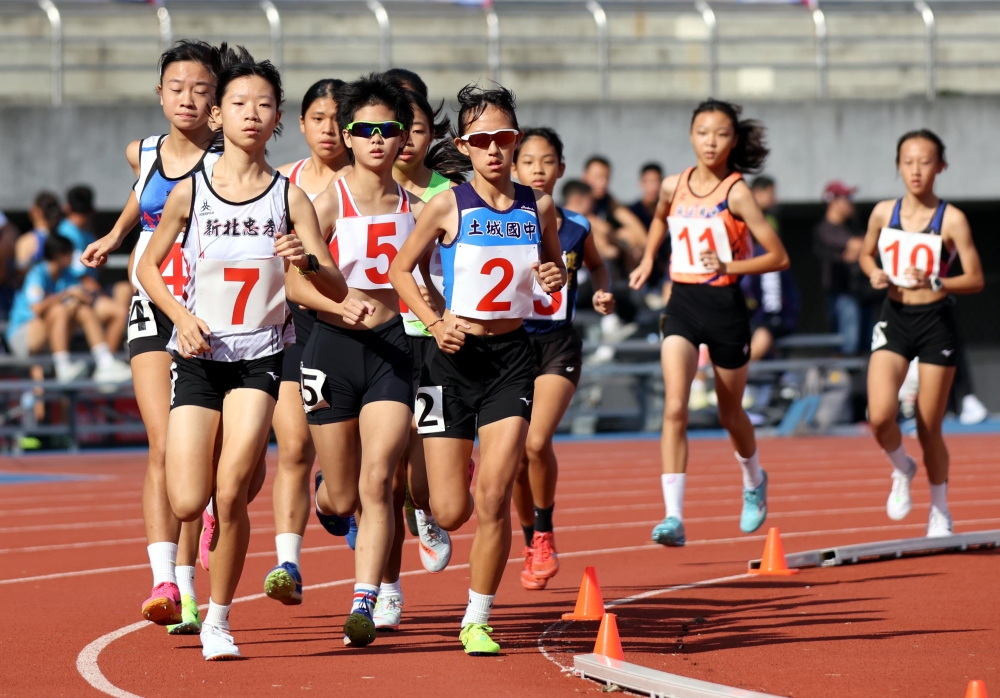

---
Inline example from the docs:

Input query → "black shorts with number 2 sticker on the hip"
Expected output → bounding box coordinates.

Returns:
[414,327,535,441]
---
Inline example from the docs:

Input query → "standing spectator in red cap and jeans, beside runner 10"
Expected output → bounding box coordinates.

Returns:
[813,180,866,355]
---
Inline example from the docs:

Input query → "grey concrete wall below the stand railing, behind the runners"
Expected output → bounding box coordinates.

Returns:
[0,98,1000,210]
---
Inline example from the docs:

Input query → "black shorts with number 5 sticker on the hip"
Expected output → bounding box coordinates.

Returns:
[301,316,413,424]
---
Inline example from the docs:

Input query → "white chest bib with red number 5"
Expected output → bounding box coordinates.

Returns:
[330,213,414,290]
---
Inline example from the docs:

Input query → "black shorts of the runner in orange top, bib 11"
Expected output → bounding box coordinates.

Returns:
[660,281,750,369]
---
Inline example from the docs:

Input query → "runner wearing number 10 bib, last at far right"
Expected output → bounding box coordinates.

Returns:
[858,129,984,537]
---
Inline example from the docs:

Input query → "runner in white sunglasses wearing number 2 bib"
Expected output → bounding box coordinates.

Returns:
[389,85,566,655]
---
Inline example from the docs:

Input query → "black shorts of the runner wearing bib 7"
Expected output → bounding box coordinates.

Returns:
[170,351,284,412]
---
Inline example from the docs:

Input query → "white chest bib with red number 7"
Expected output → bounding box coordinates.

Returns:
[195,257,285,332]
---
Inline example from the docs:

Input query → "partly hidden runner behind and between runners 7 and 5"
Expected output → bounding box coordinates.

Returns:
[264,78,351,605]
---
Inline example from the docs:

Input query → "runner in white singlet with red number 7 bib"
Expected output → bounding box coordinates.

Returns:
[136,47,346,660]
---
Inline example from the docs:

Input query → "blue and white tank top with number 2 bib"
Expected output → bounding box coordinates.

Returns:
[440,182,541,320]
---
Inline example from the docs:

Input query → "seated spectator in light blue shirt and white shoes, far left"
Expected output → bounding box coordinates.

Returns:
[6,234,132,383]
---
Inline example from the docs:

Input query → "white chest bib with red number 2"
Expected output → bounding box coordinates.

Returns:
[451,242,538,320]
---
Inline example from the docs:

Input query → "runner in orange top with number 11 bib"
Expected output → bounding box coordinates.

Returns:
[629,99,788,546]
